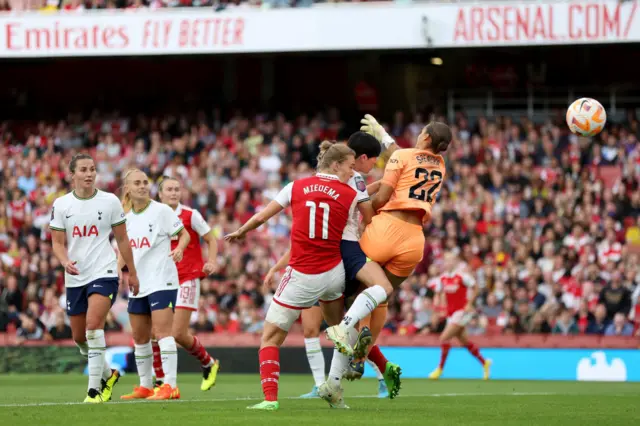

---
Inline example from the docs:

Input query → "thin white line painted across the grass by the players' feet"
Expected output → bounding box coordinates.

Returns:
[0,392,556,408]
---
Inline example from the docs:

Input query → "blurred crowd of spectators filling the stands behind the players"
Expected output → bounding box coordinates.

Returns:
[0,109,640,339]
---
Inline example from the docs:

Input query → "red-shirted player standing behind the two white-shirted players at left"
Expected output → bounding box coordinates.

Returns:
[151,176,220,391]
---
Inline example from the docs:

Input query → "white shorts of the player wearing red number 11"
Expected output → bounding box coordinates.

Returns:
[273,262,344,309]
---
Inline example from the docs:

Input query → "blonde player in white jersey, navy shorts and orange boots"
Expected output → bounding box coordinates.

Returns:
[118,169,190,400]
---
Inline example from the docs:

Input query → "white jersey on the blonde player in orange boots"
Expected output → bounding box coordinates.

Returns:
[126,200,184,299]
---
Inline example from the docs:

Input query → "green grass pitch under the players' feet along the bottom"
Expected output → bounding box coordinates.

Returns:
[0,374,640,426]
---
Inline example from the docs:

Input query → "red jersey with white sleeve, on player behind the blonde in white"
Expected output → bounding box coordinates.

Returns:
[171,204,211,284]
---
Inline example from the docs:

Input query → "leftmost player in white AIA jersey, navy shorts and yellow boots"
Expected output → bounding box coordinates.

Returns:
[49,154,139,403]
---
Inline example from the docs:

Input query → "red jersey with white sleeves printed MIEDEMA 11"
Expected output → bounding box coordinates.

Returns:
[275,173,357,274]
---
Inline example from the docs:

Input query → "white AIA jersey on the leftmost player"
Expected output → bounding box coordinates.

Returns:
[49,189,125,287]
